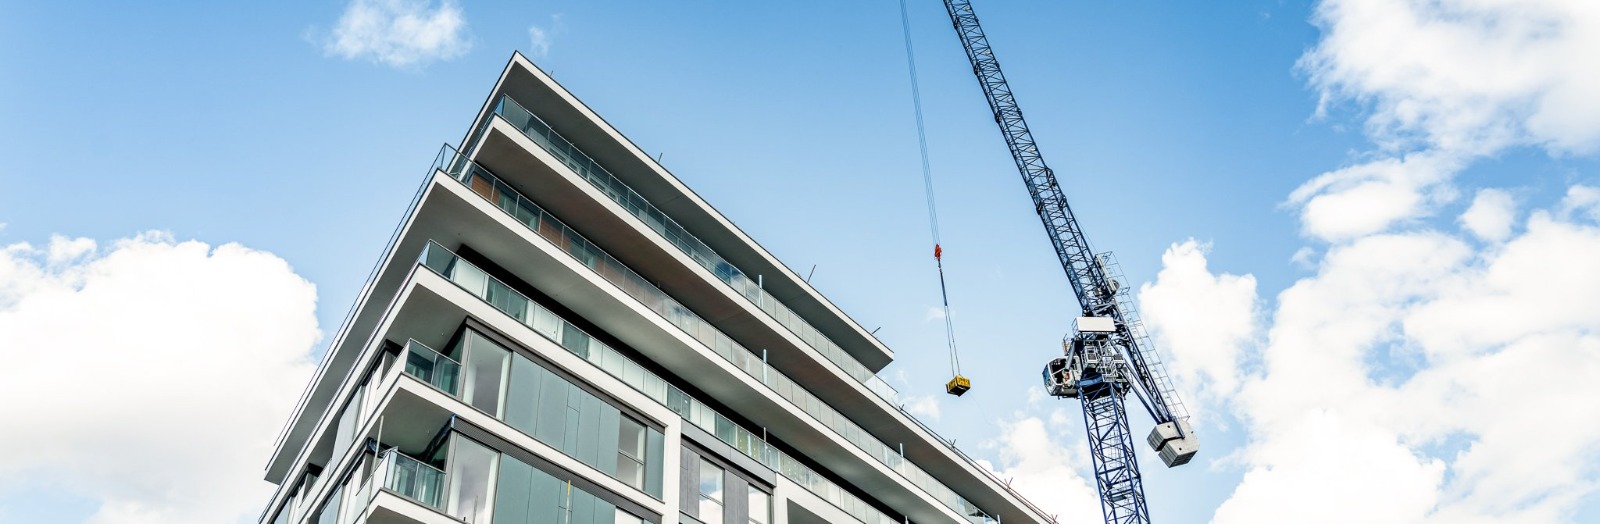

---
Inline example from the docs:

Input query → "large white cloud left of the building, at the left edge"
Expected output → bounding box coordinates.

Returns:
[0,233,320,522]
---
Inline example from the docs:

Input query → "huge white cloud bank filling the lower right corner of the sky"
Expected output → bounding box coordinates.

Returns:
[1216,211,1600,522]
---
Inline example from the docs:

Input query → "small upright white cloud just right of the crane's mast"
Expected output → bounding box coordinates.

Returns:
[1139,240,1258,415]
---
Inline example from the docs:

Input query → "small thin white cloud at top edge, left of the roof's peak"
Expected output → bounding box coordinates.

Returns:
[323,0,472,69]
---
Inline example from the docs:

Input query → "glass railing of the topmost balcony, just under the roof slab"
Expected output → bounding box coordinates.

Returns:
[494,96,896,404]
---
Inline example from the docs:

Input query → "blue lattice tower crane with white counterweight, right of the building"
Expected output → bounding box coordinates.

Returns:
[944,0,1200,524]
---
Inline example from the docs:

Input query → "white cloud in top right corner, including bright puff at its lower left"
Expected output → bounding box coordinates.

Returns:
[1290,0,1600,241]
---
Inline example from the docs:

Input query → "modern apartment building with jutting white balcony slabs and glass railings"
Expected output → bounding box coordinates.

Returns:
[261,54,1050,524]
